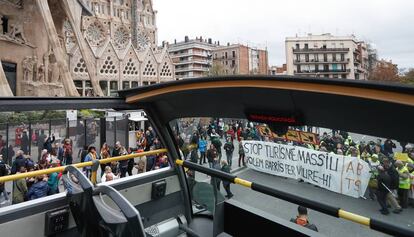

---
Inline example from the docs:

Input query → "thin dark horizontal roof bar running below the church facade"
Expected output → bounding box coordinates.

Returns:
[0,97,136,112]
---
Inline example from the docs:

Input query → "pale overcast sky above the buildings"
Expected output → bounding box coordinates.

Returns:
[153,0,414,68]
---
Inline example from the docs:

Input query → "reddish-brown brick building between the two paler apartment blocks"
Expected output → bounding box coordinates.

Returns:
[212,44,268,75]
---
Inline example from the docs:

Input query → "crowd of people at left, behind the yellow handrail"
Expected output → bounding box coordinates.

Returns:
[0,127,170,206]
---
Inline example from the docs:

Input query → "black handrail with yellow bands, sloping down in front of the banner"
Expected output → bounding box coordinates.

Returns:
[175,160,414,237]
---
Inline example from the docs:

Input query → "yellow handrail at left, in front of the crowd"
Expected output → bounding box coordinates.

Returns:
[0,149,168,183]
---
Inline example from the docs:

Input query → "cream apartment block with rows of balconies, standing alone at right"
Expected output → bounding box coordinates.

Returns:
[285,34,369,80]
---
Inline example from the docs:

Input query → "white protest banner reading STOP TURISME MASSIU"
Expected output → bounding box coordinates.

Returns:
[242,141,371,198]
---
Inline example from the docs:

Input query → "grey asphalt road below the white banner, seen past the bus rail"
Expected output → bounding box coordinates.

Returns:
[196,168,414,237]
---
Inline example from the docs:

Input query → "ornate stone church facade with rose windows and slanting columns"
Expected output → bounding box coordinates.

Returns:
[0,0,175,96]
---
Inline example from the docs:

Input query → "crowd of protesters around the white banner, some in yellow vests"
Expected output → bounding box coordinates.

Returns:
[176,119,414,215]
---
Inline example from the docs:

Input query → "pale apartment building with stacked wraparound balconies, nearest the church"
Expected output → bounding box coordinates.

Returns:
[169,36,218,79]
